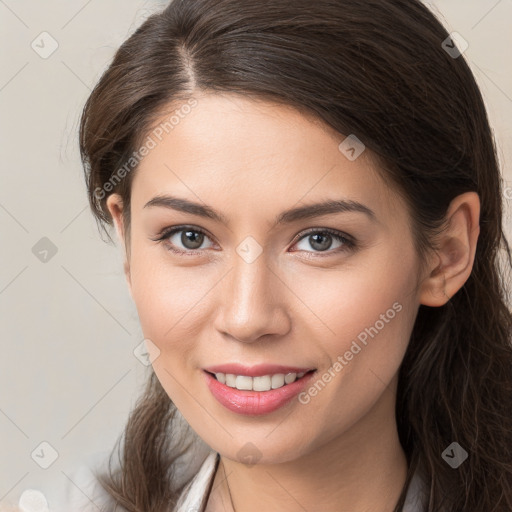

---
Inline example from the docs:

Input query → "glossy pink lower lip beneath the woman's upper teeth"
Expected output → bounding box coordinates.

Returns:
[203,371,316,416]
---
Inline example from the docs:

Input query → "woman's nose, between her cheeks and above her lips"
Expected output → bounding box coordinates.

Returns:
[215,249,291,343]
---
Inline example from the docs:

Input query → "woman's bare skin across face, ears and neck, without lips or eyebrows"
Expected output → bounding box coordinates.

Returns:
[107,93,479,512]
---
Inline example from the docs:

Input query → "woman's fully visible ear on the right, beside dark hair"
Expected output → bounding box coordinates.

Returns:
[420,192,480,307]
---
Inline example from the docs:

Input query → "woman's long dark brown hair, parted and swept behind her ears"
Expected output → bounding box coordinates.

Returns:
[80,0,512,512]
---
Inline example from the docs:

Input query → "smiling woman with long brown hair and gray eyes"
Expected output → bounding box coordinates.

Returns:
[73,0,512,512]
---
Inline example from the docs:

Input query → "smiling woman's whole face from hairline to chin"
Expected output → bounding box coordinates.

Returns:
[108,94,428,463]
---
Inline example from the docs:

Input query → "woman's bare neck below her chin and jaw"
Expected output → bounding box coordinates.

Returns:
[207,372,407,512]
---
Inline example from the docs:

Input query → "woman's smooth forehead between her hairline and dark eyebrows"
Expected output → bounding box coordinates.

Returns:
[132,94,404,224]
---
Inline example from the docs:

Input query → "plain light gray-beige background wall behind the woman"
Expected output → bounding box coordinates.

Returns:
[0,0,512,502]
